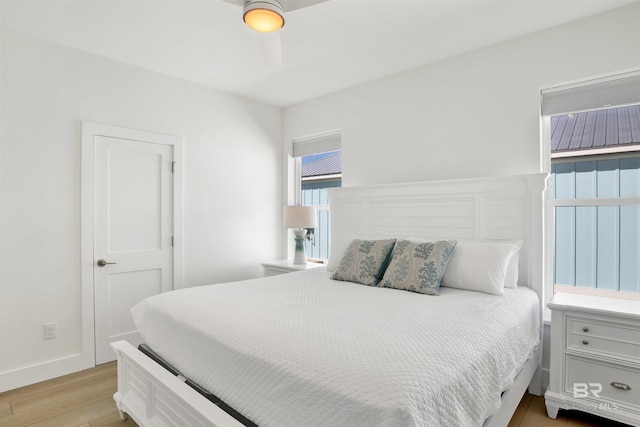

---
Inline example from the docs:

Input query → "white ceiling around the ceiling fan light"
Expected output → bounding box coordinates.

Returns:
[1,0,637,106]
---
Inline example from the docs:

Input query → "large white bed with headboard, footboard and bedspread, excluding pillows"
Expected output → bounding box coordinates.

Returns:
[113,174,546,426]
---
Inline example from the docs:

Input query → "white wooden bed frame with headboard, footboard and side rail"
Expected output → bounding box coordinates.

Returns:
[112,174,547,427]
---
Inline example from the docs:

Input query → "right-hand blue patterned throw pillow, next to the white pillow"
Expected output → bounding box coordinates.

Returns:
[380,240,457,295]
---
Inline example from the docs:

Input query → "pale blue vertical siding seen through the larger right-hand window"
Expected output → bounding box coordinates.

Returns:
[551,157,640,292]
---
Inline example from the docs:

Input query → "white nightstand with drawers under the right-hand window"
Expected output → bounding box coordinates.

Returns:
[544,293,640,426]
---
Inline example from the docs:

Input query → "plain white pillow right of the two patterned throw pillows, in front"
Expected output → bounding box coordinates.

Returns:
[442,242,516,295]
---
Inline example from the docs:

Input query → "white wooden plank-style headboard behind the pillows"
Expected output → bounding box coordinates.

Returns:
[328,174,548,299]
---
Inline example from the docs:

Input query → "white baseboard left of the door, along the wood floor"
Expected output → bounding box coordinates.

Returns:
[0,354,84,393]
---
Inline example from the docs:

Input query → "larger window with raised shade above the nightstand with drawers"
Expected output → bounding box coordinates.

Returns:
[542,73,640,299]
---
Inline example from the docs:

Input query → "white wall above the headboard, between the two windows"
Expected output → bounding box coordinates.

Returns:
[283,3,640,186]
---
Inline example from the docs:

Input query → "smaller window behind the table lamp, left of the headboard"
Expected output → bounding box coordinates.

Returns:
[293,132,342,261]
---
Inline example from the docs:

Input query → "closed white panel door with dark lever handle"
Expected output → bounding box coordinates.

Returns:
[93,136,173,364]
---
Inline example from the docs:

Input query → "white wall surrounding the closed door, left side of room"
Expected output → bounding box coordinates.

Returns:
[0,31,282,391]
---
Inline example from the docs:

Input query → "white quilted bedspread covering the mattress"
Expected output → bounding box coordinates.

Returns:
[132,269,539,427]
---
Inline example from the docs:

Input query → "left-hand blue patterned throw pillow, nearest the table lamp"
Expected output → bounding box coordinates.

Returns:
[331,239,396,286]
